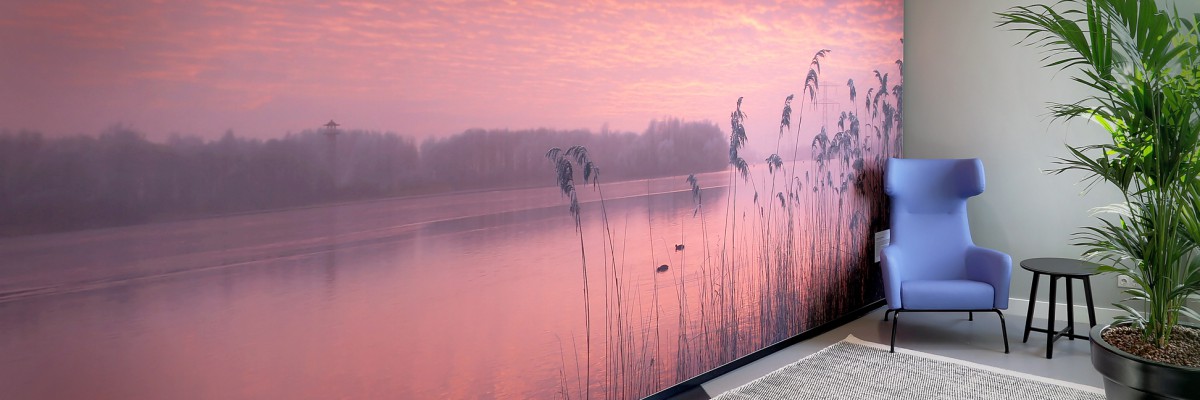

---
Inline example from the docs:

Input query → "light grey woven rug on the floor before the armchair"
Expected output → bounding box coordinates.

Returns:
[714,336,1104,400]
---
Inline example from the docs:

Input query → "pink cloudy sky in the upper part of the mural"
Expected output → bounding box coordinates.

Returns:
[0,0,902,143]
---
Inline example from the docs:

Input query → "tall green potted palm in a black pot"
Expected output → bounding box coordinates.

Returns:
[997,0,1200,399]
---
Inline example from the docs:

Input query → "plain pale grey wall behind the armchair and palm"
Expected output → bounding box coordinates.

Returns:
[904,0,1200,314]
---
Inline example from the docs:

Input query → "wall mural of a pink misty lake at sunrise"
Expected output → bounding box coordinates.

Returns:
[0,0,902,399]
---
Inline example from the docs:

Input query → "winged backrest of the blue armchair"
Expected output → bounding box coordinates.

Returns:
[884,159,984,279]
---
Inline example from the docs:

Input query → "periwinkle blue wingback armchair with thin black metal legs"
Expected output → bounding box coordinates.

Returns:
[882,159,1013,353]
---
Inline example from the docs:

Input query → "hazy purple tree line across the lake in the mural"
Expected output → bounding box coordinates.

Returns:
[0,119,726,235]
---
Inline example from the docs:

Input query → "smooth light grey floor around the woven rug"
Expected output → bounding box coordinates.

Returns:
[678,308,1104,399]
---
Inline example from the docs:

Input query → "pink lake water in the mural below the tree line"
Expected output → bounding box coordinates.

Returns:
[0,163,883,399]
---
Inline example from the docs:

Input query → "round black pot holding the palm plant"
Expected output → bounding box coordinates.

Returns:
[1091,326,1200,400]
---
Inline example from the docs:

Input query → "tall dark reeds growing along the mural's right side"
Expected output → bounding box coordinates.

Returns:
[546,42,902,399]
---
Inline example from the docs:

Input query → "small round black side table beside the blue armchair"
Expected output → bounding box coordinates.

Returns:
[1021,258,1098,358]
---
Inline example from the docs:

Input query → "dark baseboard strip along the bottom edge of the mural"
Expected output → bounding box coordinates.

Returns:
[646,299,887,400]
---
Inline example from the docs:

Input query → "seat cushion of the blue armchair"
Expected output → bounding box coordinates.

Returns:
[900,280,996,310]
